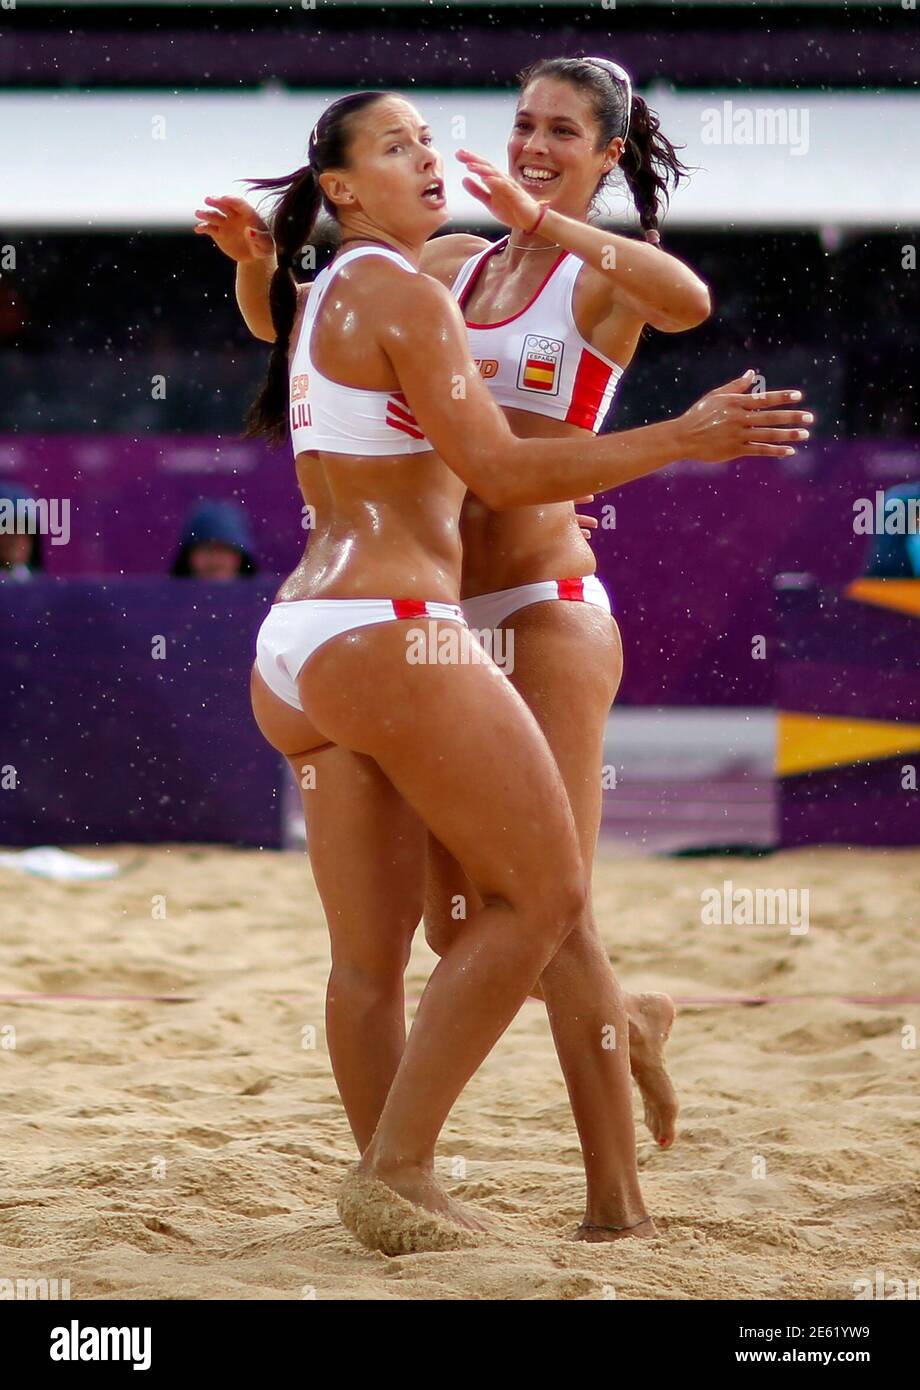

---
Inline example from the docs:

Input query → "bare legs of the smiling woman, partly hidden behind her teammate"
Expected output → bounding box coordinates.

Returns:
[427,603,677,1238]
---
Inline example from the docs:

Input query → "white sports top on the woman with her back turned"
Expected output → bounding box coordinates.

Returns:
[288,246,432,459]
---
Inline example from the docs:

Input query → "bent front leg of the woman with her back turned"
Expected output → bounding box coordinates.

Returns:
[299,623,594,1211]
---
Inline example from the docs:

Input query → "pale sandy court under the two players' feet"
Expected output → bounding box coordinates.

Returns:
[0,847,920,1300]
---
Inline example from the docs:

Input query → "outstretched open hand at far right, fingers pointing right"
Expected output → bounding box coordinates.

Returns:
[678,371,814,463]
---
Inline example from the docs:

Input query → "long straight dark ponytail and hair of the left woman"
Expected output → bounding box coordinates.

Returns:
[243,92,388,443]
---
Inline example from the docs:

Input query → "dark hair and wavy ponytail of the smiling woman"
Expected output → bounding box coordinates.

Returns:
[520,58,689,242]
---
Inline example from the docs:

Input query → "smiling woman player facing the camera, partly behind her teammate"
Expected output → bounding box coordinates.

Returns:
[202,58,709,1167]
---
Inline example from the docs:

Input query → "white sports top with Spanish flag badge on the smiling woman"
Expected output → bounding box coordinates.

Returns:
[452,236,623,434]
